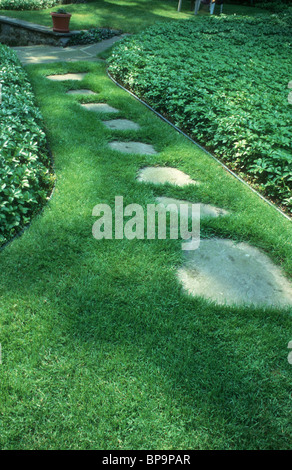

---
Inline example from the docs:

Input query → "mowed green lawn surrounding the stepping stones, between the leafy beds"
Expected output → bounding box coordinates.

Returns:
[0,63,291,450]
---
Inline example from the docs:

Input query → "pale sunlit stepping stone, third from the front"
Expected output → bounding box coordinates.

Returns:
[137,166,199,186]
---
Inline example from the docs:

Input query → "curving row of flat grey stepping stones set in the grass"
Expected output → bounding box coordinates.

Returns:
[47,73,292,306]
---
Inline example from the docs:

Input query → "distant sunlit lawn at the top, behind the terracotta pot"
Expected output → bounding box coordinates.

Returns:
[0,0,265,33]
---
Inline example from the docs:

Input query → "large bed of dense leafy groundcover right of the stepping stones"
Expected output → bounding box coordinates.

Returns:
[109,15,292,211]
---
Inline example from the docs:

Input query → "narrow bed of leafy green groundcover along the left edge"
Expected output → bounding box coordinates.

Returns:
[0,45,52,245]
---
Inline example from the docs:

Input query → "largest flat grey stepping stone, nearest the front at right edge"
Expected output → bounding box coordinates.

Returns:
[177,238,292,307]
